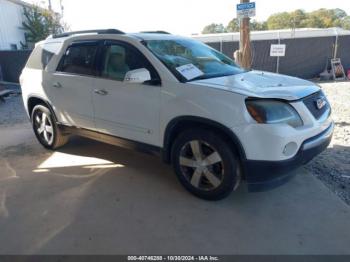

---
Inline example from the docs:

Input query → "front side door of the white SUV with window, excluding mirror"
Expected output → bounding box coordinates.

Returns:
[93,41,160,145]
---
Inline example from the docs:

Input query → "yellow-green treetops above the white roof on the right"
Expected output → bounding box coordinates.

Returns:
[202,8,350,34]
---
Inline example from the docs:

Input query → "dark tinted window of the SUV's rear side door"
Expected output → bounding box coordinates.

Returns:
[57,44,97,75]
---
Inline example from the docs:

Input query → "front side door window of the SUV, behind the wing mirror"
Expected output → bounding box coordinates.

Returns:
[101,43,159,81]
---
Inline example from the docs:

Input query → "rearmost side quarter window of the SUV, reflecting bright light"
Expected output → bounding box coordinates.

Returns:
[26,43,62,70]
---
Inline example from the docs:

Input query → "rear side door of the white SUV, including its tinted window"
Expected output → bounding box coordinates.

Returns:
[44,41,98,129]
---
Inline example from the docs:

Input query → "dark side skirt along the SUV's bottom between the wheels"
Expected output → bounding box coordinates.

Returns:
[58,124,162,156]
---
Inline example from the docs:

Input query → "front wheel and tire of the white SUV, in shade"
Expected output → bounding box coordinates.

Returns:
[171,129,241,200]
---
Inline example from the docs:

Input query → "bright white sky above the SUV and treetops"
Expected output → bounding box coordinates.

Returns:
[25,0,350,35]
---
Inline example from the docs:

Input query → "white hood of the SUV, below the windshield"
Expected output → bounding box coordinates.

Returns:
[191,71,320,100]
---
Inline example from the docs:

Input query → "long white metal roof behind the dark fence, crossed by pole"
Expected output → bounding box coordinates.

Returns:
[191,27,350,43]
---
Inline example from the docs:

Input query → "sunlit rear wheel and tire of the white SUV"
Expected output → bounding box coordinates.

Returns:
[31,104,69,149]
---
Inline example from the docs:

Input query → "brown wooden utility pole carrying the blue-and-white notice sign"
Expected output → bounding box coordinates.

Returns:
[237,0,252,69]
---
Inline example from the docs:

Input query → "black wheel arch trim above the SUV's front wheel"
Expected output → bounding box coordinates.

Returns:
[162,116,246,163]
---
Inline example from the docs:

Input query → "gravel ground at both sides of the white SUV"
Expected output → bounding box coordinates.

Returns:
[0,82,350,205]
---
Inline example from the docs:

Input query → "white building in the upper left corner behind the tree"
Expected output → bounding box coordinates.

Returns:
[0,0,31,50]
